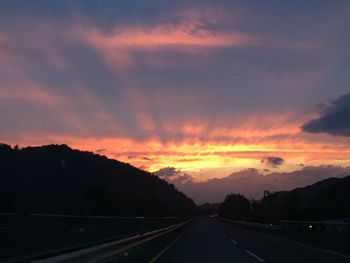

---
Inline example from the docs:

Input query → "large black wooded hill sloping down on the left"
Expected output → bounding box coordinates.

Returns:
[0,144,196,216]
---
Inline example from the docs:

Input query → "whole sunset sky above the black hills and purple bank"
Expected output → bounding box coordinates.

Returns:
[0,0,350,186]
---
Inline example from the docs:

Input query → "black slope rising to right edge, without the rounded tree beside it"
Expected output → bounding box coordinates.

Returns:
[261,176,350,222]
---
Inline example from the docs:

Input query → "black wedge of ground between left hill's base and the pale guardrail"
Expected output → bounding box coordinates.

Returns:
[0,213,189,262]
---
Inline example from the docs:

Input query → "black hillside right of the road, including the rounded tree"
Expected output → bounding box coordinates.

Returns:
[218,176,350,224]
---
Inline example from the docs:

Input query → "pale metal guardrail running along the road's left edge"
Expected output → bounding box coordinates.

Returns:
[3,219,193,263]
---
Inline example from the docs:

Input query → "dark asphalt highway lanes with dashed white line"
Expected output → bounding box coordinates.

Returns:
[149,218,350,263]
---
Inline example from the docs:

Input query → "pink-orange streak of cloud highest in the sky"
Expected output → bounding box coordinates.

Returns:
[79,12,253,69]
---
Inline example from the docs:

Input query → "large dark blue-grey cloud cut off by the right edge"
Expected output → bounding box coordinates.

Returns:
[301,92,350,136]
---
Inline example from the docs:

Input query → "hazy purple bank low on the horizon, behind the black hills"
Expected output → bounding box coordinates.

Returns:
[167,165,350,204]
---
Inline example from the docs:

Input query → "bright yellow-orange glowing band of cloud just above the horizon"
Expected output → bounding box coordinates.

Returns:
[8,117,350,180]
